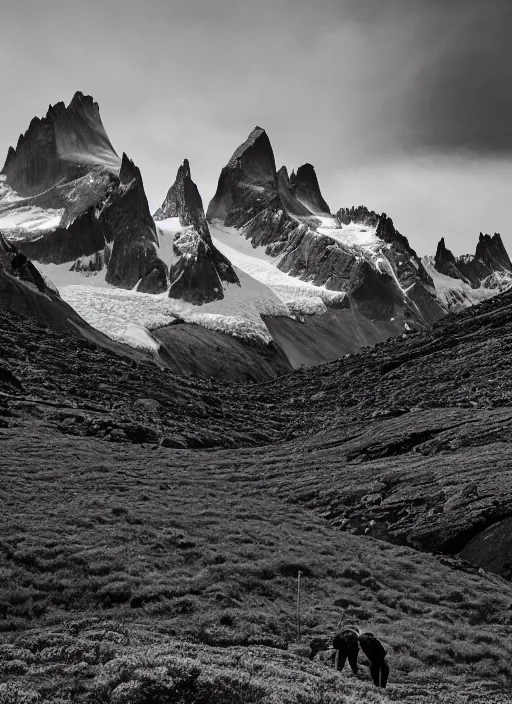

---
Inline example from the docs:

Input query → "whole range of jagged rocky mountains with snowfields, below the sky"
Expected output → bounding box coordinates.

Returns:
[0,93,512,380]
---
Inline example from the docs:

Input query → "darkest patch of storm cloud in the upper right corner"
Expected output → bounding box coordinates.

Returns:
[406,0,512,154]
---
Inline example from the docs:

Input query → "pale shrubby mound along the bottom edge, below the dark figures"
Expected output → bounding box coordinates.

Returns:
[0,618,507,704]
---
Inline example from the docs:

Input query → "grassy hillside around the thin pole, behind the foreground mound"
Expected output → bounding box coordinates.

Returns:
[0,421,512,701]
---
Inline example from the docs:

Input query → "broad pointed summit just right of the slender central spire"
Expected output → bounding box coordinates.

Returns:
[206,127,277,227]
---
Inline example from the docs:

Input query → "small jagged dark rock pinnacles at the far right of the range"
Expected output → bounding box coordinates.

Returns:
[434,233,512,288]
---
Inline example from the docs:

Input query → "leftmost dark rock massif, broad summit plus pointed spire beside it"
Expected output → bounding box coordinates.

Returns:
[0,93,168,293]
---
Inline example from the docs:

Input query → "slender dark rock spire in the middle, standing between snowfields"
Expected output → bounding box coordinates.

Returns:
[155,159,240,305]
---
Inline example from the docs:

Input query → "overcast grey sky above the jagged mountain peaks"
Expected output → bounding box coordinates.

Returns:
[0,0,512,255]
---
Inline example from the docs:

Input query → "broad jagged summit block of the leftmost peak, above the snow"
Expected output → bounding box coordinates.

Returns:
[2,92,120,196]
